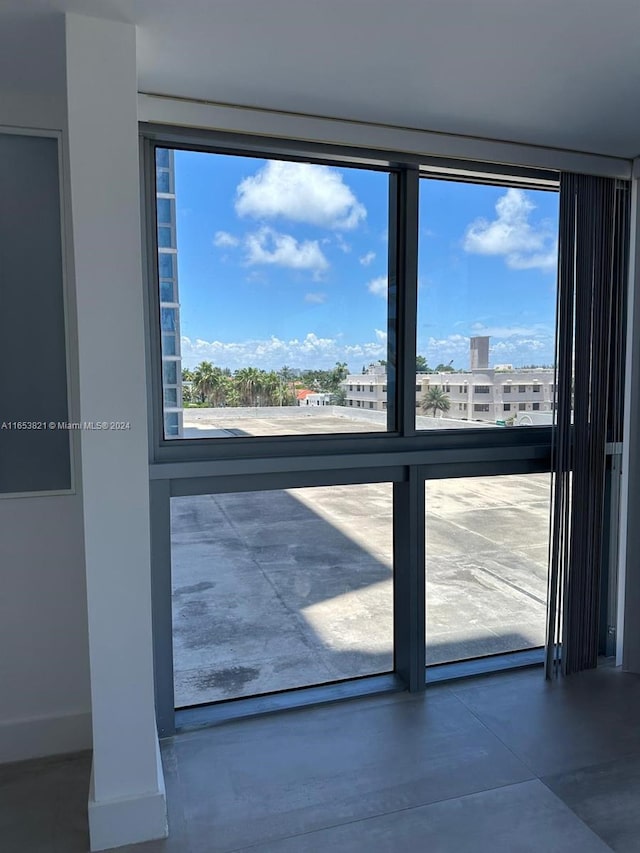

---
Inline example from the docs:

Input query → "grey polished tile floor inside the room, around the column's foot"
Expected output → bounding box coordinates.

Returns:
[5,667,640,853]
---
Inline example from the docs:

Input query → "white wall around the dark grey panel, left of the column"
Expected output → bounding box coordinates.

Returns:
[0,11,91,762]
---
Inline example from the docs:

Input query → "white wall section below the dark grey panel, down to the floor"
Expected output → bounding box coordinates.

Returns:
[0,496,91,761]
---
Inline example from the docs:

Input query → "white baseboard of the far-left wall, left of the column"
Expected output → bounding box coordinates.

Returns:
[0,712,92,764]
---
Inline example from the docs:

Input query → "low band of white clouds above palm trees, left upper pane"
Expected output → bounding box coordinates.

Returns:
[182,332,387,370]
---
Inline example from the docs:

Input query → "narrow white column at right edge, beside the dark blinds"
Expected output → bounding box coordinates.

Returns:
[616,160,640,672]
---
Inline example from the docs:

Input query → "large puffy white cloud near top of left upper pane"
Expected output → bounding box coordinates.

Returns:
[235,160,367,229]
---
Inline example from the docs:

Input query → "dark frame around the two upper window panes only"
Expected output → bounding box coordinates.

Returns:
[141,125,558,464]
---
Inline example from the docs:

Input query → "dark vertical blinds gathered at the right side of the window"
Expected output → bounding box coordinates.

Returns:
[546,174,628,677]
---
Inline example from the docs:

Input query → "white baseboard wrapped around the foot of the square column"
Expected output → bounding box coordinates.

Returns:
[89,736,169,851]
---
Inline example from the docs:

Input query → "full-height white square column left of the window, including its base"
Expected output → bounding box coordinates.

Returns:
[66,15,167,850]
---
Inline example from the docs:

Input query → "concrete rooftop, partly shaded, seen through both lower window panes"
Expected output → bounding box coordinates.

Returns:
[172,475,549,707]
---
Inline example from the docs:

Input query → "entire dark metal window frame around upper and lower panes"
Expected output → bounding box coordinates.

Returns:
[141,125,559,736]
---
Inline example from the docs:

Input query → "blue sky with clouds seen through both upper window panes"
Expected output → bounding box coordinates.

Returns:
[169,152,558,372]
